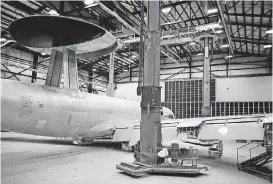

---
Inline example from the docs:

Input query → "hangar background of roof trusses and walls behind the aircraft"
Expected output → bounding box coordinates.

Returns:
[1,1,272,118]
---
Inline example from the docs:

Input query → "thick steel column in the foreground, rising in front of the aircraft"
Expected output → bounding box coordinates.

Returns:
[140,1,162,164]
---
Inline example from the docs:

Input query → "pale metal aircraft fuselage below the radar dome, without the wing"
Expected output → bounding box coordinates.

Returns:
[1,79,174,145]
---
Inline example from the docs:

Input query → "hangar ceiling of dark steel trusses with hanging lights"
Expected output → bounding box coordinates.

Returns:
[1,0,272,80]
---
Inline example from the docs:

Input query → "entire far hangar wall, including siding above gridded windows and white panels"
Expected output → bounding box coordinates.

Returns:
[115,54,272,118]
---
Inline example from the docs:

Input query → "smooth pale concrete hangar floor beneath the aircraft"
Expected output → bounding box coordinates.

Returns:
[1,132,269,184]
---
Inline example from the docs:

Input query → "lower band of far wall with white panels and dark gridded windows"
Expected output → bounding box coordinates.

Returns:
[115,76,272,118]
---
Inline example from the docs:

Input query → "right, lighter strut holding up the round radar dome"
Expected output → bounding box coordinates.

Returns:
[63,48,78,90]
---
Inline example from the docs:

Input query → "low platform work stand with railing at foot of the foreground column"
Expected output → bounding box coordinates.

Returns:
[116,144,209,177]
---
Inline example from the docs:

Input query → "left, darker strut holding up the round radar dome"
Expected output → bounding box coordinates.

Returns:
[45,49,63,87]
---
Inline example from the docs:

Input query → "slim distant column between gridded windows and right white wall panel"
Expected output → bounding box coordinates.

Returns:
[202,37,210,117]
